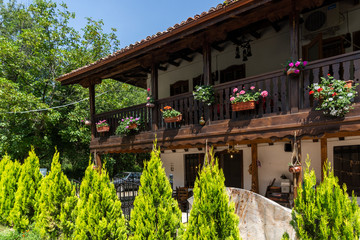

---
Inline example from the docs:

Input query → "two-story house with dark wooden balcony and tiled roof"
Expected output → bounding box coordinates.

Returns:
[58,0,360,199]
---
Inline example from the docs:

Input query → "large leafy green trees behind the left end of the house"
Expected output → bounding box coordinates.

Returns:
[0,0,146,178]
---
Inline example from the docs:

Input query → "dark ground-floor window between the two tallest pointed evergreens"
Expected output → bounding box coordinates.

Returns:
[185,153,205,187]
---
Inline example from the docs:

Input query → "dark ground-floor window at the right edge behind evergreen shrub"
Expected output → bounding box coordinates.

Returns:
[334,145,360,196]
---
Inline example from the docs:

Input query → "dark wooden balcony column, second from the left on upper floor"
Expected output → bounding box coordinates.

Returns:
[150,62,160,131]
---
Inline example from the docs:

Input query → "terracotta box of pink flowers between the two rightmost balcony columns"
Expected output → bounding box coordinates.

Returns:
[230,86,269,111]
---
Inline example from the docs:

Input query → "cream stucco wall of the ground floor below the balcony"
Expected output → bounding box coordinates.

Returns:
[161,136,360,200]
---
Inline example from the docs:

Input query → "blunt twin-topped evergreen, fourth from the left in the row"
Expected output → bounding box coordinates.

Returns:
[70,164,127,240]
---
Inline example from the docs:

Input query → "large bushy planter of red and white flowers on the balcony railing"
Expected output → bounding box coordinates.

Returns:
[309,74,358,117]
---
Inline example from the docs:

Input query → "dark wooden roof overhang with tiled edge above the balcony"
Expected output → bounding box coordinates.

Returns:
[57,0,324,87]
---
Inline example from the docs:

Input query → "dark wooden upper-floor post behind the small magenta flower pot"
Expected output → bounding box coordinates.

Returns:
[288,0,300,113]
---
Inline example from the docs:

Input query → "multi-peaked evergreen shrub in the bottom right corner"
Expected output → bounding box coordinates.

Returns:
[291,156,360,240]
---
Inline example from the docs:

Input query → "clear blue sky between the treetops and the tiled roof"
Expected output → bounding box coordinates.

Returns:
[18,0,221,48]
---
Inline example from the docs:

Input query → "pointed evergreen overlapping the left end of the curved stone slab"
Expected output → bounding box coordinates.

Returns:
[184,150,240,240]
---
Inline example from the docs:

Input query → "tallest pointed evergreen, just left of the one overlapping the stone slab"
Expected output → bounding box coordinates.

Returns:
[129,140,181,240]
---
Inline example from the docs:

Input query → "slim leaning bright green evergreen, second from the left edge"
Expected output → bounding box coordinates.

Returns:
[8,149,42,230]
